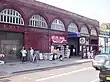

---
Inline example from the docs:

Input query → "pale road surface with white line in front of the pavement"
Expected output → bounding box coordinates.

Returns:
[0,62,99,82]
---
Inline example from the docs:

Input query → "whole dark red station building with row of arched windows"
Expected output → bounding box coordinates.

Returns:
[0,0,99,58]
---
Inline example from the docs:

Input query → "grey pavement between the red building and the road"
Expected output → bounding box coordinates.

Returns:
[0,58,92,78]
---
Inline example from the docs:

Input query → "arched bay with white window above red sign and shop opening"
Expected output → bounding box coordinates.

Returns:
[49,19,67,57]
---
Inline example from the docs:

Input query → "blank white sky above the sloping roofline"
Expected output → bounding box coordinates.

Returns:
[37,0,110,23]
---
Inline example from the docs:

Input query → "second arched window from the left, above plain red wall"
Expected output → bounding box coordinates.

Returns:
[29,15,48,28]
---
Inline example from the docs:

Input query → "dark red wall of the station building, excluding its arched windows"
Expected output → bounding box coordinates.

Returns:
[0,0,99,52]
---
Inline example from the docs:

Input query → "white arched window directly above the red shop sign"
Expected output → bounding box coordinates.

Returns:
[51,19,65,31]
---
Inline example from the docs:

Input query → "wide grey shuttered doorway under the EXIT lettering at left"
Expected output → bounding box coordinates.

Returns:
[0,31,23,62]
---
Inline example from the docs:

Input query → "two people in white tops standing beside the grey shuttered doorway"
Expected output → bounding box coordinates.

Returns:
[20,47,36,62]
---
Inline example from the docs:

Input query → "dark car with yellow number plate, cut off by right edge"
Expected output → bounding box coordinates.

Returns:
[99,60,110,82]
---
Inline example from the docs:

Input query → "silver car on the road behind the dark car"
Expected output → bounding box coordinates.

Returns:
[92,55,109,70]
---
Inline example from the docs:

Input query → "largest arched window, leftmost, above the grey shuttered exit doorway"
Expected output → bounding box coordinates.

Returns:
[0,9,24,25]
